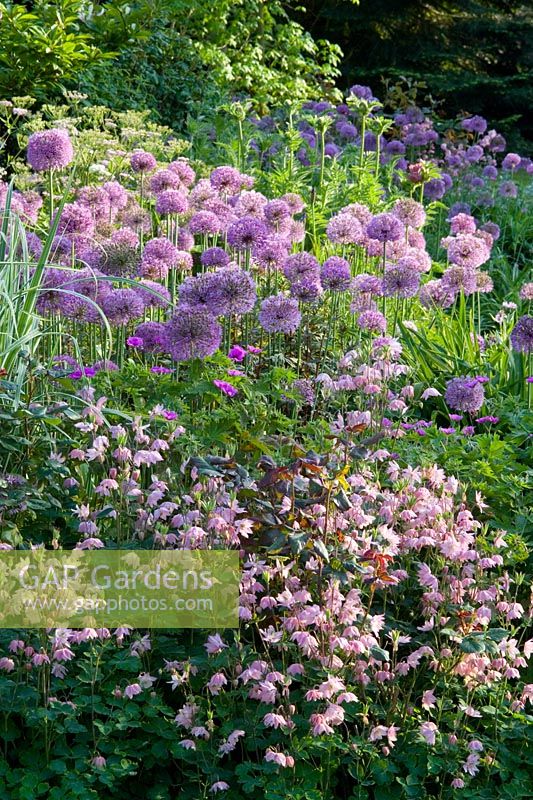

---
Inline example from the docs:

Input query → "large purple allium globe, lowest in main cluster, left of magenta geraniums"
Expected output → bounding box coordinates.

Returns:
[166,308,222,361]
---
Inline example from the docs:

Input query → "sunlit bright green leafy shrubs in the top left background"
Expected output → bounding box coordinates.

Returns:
[0,0,341,129]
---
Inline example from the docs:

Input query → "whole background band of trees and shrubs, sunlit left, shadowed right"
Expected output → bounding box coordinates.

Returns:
[0,0,533,154]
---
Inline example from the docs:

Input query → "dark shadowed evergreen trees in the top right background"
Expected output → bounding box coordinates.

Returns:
[299,0,533,150]
